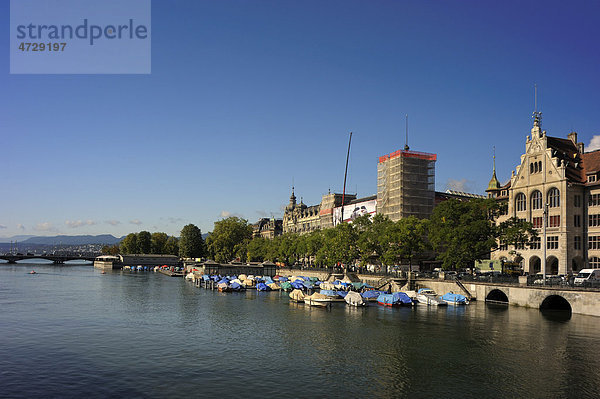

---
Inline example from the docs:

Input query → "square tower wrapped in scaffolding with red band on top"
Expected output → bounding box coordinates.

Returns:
[377,146,437,221]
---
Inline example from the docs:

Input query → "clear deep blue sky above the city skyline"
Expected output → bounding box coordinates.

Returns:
[0,0,600,237]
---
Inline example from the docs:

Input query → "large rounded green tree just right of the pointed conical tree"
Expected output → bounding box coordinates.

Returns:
[206,216,252,263]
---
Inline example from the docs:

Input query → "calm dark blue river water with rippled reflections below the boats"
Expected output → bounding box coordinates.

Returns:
[0,264,600,398]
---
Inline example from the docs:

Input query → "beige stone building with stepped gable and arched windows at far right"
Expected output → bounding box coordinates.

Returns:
[486,113,600,274]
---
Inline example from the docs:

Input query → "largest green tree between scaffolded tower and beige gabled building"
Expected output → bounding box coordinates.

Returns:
[429,199,498,269]
